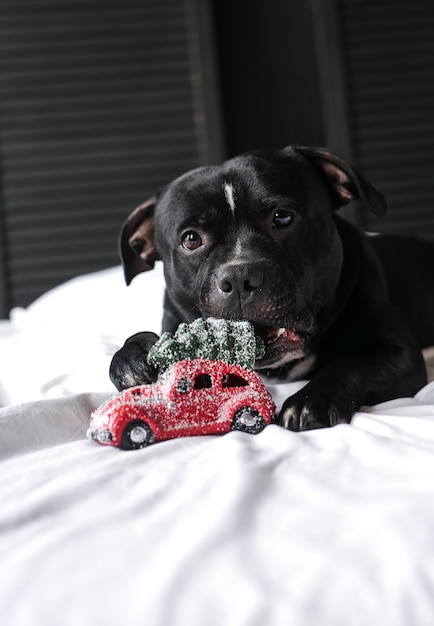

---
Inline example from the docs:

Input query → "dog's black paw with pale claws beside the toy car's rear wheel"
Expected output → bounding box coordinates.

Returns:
[278,383,356,431]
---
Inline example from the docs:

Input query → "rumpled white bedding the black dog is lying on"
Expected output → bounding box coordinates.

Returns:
[0,268,434,626]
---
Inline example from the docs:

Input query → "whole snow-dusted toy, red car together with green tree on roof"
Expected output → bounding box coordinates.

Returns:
[87,319,276,449]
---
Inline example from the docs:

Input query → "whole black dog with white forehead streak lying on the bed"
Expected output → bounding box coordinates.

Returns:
[110,147,434,430]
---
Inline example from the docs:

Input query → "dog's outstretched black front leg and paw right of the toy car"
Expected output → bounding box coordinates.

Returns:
[279,346,426,431]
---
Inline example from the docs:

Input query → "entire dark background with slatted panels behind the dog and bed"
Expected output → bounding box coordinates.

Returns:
[0,0,434,315]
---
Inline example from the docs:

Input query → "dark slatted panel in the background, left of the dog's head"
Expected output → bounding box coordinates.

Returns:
[0,0,220,309]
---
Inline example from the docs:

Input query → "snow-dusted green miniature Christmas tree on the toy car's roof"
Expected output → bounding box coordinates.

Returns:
[148,318,265,369]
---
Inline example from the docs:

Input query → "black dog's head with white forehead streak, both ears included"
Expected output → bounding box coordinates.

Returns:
[121,147,385,367]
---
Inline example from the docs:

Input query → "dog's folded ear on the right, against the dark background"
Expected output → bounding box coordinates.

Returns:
[295,146,387,216]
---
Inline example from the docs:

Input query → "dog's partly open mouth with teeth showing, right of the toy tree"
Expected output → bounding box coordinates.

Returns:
[254,324,308,369]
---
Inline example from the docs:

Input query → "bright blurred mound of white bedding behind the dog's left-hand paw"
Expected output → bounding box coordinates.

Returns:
[0,264,164,406]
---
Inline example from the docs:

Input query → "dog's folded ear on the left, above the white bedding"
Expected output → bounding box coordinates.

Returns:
[119,197,160,285]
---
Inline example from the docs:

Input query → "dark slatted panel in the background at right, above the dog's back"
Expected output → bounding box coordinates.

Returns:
[338,0,434,234]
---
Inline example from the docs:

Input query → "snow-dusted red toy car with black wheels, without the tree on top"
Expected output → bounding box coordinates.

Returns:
[87,359,276,450]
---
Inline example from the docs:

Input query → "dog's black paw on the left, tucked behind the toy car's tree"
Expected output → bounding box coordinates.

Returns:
[110,332,158,391]
